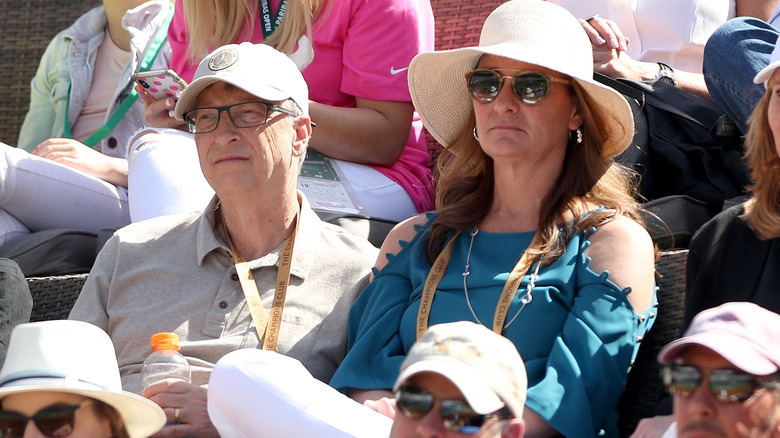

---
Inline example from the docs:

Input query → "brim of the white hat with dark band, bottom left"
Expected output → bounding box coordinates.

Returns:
[0,378,166,438]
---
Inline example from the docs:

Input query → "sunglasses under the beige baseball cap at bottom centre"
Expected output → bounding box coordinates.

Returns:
[395,386,509,435]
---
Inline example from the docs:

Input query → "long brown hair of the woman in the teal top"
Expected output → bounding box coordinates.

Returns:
[426,80,642,263]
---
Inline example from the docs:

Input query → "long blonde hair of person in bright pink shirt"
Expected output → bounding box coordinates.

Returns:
[183,0,327,64]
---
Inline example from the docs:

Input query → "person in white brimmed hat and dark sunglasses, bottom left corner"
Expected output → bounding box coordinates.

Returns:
[0,320,165,438]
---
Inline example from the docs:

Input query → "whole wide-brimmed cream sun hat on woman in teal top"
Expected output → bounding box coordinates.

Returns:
[409,0,634,157]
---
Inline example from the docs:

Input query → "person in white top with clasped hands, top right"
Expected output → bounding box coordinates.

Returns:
[548,0,777,98]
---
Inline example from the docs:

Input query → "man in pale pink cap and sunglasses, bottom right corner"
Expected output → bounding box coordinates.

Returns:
[658,302,780,438]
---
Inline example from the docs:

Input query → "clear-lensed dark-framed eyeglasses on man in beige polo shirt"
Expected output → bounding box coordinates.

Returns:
[184,102,297,134]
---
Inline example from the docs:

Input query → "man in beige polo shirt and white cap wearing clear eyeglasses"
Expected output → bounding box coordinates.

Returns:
[70,43,377,437]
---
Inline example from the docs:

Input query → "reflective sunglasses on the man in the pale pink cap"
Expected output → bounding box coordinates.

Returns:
[661,365,780,403]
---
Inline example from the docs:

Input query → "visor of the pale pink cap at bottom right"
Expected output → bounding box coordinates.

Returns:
[658,332,779,376]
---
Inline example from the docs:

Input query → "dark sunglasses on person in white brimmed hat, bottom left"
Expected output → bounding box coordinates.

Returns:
[0,400,94,438]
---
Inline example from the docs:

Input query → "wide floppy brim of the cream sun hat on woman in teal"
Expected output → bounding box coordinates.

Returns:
[408,43,634,158]
